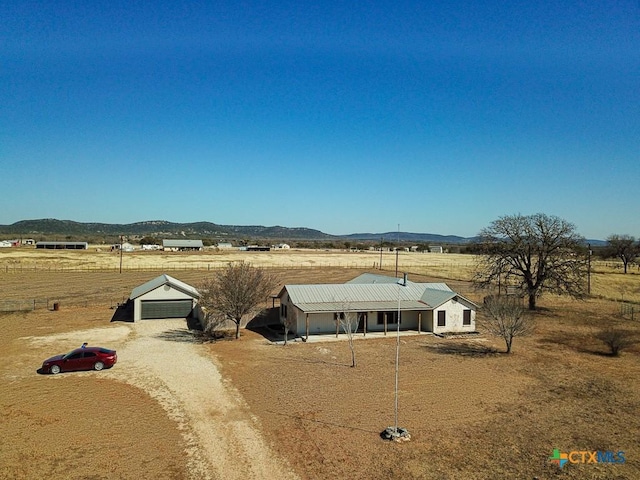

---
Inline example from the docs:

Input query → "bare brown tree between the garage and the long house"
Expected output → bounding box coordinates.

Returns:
[200,262,278,338]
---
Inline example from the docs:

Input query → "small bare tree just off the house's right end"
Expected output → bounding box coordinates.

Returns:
[483,295,534,353]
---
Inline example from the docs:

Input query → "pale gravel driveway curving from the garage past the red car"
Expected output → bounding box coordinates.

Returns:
[25,320,297,479]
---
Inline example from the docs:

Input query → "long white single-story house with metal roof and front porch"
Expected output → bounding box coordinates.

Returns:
[278,274,477,337]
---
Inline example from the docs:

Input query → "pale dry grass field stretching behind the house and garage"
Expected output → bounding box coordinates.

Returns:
[0,247,640,304]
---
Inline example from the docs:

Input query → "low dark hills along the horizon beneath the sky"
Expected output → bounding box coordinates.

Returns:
[0,218,474,244]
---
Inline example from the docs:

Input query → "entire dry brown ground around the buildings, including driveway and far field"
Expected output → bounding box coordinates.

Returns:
[0,249,640,480]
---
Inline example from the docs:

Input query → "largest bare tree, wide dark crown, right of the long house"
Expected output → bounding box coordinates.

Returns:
[473,213,587,310]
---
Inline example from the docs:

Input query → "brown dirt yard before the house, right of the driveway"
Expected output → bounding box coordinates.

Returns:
[210,299,640,480]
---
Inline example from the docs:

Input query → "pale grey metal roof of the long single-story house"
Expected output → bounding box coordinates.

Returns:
[279,282,464,313]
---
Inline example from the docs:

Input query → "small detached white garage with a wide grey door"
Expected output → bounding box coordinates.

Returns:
[129,274,200,322]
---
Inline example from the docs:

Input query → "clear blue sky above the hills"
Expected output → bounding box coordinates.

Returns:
[0,0,640,239]
